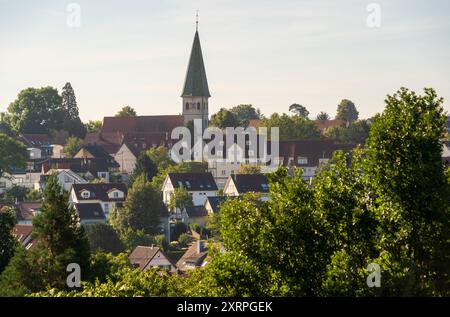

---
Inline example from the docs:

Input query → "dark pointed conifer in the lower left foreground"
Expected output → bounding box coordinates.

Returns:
[30,174,90,288]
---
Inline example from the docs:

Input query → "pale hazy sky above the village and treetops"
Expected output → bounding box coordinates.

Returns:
[0,0,450,120]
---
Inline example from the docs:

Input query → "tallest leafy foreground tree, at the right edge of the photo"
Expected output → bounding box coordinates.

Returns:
[363,88,450,295]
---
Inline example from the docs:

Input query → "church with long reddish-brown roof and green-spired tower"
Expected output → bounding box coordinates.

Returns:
[84,21,211,155]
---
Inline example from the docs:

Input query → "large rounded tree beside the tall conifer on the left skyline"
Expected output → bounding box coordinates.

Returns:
[8,87,64,134]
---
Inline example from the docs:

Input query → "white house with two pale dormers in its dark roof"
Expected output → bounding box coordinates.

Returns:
[69,183,127,217]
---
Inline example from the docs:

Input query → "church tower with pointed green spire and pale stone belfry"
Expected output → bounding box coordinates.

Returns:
[181,19,211,129]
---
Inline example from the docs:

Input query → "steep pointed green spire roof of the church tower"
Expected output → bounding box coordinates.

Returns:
[182,31,211,97]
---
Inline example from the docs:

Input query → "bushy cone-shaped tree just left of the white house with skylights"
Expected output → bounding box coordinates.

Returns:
[116,175,165,234]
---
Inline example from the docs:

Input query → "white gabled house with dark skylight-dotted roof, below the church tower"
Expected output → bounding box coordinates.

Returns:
[162,173,218,206]
